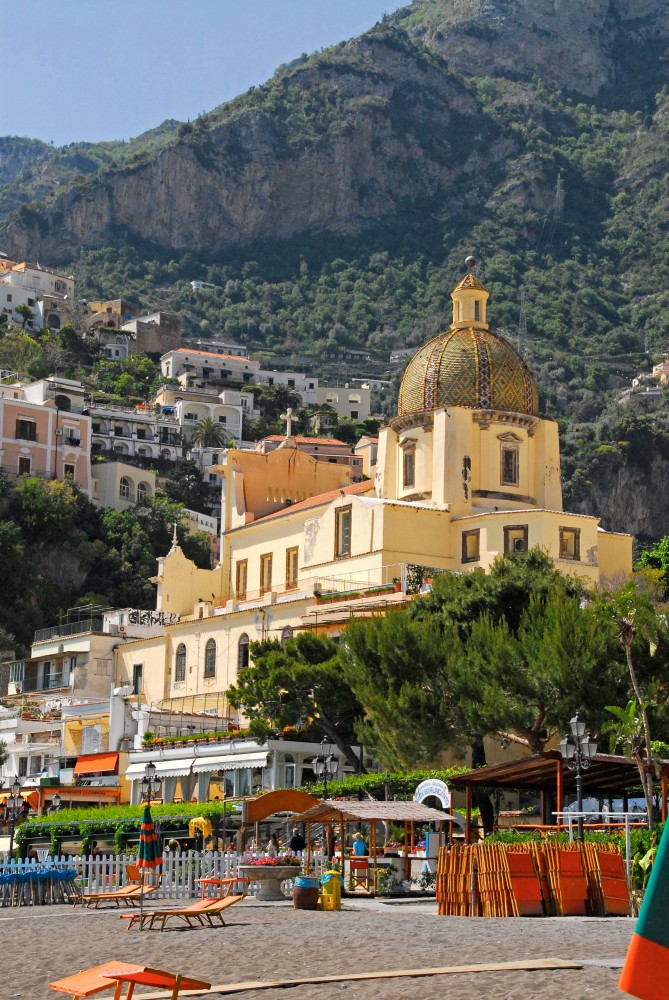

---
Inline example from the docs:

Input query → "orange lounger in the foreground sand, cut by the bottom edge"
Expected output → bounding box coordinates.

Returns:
[49,962,211,1000]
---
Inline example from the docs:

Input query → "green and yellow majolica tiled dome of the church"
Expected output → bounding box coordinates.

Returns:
[397,326,539,417]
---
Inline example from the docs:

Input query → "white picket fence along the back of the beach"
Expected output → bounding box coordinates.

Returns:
[0,851,323,899]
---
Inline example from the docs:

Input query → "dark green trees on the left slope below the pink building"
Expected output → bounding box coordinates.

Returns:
[0,472,210,655]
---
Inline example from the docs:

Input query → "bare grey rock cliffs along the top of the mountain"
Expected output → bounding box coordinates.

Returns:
[0,0,669,262]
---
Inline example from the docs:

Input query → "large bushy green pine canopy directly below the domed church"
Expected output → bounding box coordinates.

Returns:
[341,552,624,766]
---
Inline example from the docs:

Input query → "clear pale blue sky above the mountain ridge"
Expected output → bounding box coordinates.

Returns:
[0,0,408,146]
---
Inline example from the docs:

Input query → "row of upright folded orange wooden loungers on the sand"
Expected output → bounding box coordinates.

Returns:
[437,841,631,917]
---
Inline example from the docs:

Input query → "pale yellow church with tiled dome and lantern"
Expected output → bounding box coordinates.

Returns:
[116,258,632,794]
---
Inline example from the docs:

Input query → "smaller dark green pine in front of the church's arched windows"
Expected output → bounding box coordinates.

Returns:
[228,632,364,771]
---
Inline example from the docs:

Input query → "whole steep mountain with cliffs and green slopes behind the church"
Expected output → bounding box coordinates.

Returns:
[0,0,669,539]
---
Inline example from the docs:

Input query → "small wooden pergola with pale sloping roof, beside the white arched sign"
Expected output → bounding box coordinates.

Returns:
[293,799,462,886]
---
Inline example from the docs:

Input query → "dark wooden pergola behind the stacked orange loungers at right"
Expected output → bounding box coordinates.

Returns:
[450,750,669,844]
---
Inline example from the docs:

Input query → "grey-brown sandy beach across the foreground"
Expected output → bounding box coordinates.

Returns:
[0,898,634,1000]
